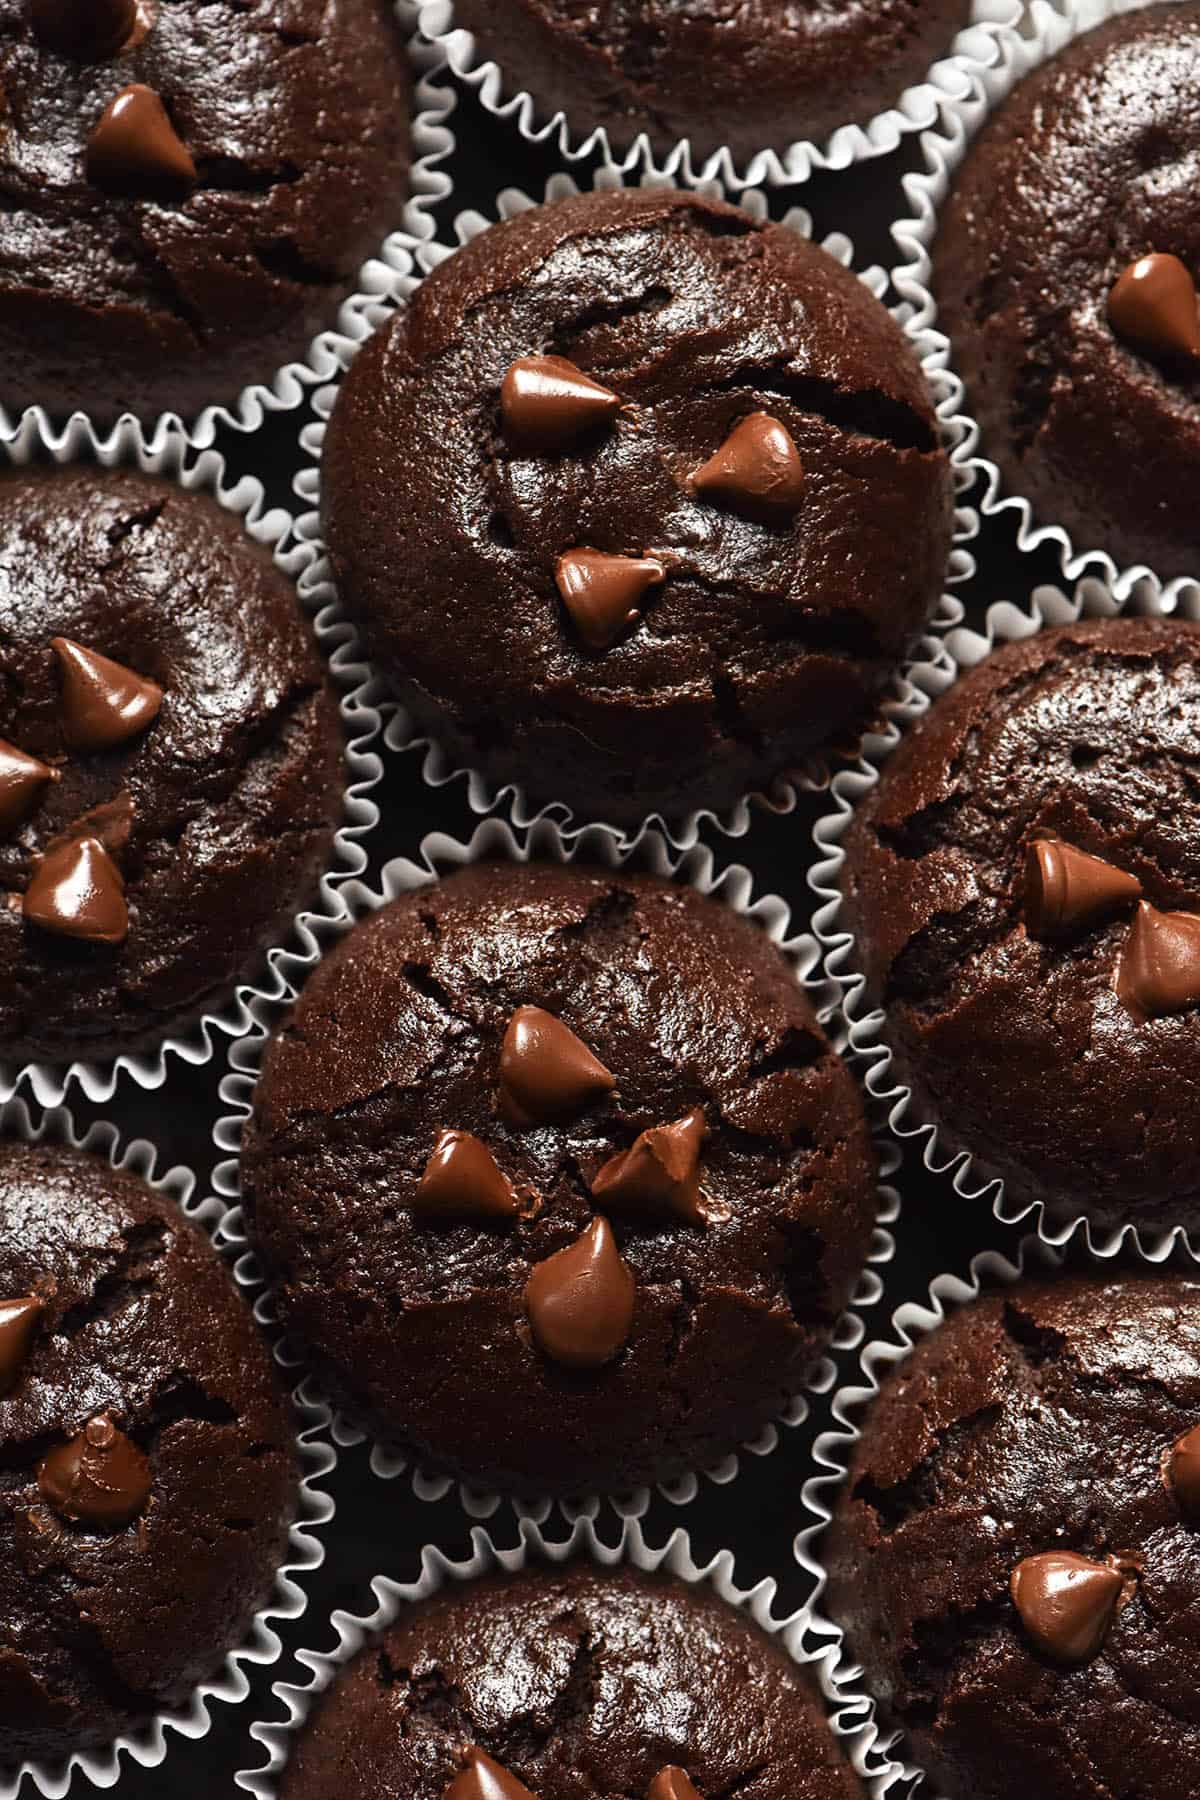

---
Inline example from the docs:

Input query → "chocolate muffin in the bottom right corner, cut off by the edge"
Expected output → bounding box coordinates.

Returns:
[817,1273,1200,1800]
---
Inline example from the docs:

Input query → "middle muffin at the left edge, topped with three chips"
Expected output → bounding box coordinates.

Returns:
[0,464,342,1064]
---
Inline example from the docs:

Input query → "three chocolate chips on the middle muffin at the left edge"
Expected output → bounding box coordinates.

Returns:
[0,637,162,943]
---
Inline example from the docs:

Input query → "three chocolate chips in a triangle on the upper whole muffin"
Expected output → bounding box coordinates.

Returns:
[500,356,804,650]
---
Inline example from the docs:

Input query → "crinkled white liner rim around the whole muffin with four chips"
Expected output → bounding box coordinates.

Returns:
[212,819,900,1521]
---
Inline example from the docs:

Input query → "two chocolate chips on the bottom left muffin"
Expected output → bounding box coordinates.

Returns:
[0,1294,151,1532]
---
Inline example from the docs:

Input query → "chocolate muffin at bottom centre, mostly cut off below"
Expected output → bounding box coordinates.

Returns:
[279,1562,862,1800]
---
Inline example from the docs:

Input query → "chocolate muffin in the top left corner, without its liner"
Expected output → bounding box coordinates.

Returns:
[0,0,410,419]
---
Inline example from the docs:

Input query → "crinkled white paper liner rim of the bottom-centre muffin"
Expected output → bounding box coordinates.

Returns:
[234,1519,895,1800]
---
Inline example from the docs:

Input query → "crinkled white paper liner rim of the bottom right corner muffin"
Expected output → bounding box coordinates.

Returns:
[793,1237,1065,1800]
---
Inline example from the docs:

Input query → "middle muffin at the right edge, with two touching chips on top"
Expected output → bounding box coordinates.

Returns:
[842,617,1200,1228]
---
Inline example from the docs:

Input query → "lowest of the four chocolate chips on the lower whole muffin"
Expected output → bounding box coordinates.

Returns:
[525,1219,633,1368]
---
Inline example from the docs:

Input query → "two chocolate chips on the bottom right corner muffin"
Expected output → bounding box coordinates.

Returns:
[1009,1426,1200,1667]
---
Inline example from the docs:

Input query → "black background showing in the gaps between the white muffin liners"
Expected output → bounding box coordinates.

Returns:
[53,66,1063,1800]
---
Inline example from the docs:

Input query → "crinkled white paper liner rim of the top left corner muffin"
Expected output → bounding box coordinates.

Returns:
[0,15,455,450]
